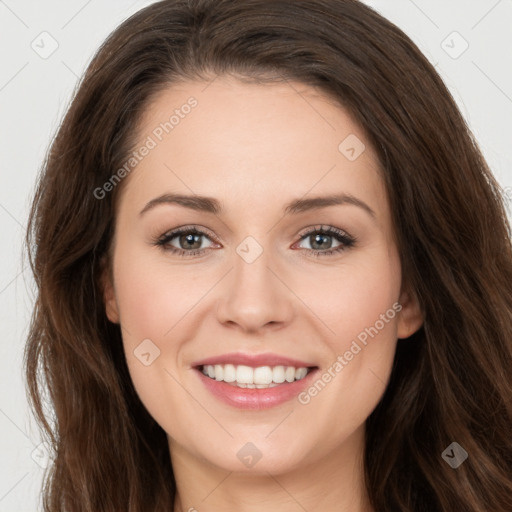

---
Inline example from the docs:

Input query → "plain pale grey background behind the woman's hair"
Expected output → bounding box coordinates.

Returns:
[0,0,512,512]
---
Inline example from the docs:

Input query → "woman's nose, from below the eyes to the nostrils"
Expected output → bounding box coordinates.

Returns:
[216,242,294,333]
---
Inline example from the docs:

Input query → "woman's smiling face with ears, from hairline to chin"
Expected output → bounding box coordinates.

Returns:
[105,77,421,474]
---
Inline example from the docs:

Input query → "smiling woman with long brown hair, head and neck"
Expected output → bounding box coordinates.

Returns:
[26,0,512,512]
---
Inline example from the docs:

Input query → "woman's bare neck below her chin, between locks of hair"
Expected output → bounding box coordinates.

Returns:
[169,426,374,512]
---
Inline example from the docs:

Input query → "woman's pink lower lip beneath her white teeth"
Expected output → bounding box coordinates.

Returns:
[197,368,318,410]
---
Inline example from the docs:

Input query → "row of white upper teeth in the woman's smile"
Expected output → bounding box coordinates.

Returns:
[202,364,308,389]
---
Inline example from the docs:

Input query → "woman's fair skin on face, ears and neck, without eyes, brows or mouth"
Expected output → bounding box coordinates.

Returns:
[104,77,422,512]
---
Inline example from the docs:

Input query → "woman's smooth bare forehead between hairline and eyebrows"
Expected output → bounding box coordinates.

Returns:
[118,77,385,220]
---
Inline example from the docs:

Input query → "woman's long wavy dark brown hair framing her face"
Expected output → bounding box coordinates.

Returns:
[25,0,512,512]
